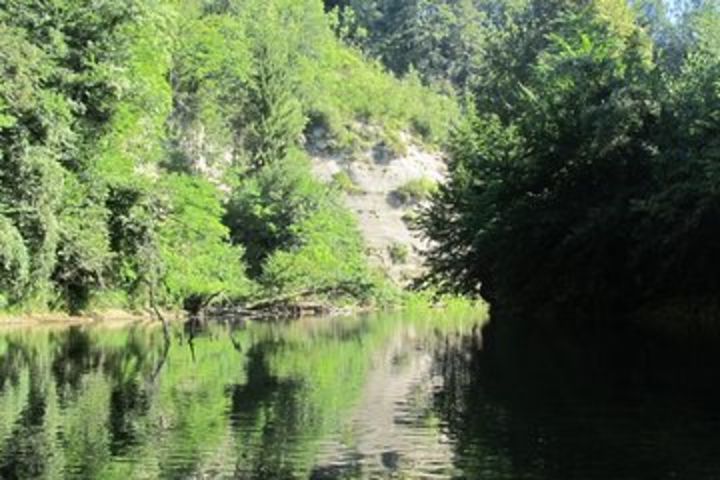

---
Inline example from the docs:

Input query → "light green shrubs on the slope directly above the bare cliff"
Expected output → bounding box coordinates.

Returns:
[298,15,459,153]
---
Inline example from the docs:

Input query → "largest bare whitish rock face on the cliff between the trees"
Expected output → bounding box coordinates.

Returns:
[308,131,447,283]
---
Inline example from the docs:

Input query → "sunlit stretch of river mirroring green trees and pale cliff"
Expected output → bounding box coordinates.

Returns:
[0,312,481,479]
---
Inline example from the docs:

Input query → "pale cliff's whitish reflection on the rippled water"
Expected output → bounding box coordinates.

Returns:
[312,335,452,479]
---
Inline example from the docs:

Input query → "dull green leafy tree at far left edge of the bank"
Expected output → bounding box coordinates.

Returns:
[0,24,73,301]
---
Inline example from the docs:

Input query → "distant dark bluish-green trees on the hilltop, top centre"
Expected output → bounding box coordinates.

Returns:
[325,0,527,90]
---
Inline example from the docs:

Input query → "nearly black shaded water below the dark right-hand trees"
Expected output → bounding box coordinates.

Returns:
[435,318,720,480]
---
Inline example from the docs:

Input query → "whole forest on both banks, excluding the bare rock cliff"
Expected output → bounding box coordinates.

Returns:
[0,0,720,334]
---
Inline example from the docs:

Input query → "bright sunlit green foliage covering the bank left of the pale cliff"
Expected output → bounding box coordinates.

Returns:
[0,0,455,311]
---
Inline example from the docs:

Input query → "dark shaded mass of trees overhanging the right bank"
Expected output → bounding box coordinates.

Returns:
[422,0,720,324]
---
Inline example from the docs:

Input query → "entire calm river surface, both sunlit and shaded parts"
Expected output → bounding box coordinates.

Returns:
[0,312,720,480]
